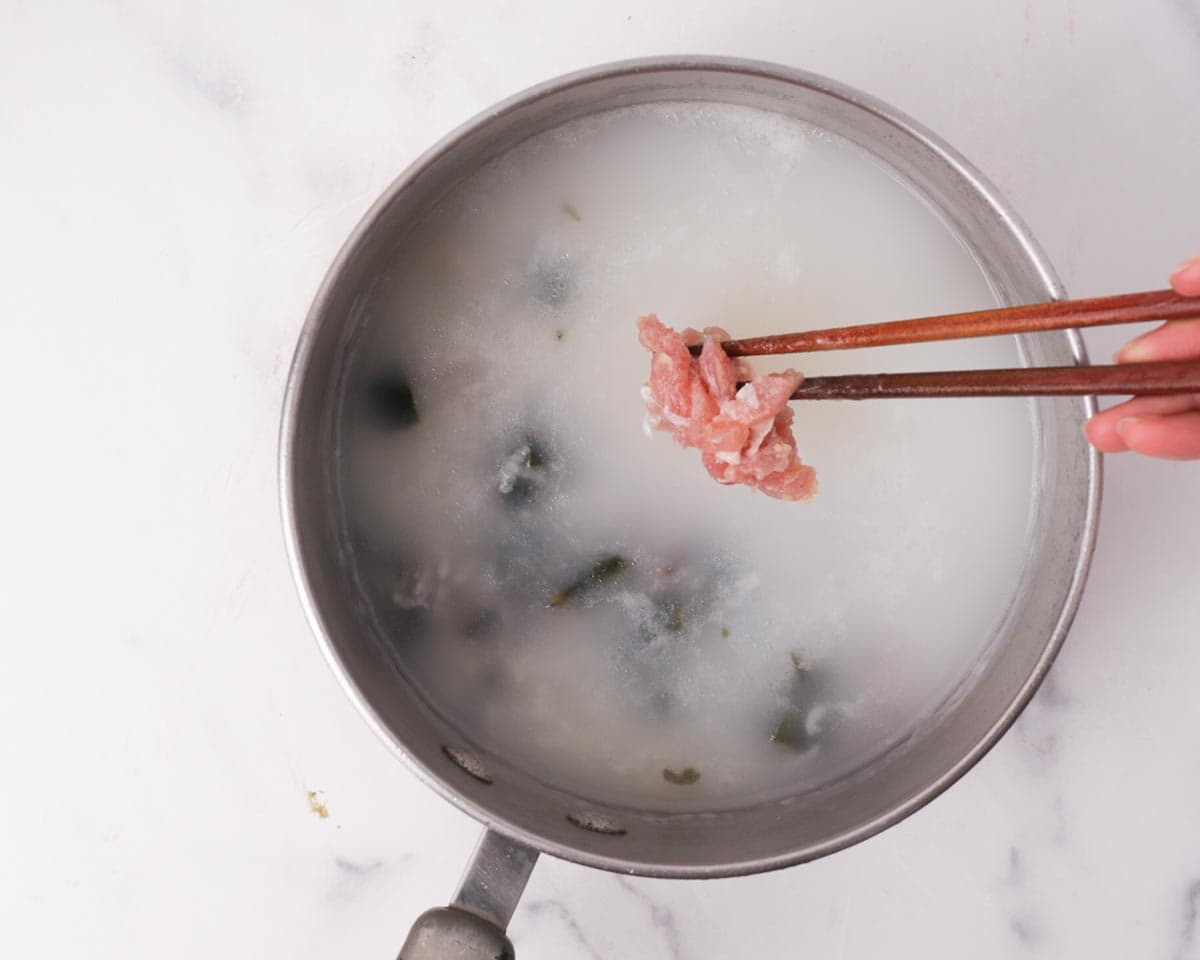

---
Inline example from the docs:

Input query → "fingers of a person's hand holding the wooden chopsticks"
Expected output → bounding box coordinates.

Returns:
[1085,256,1200,460]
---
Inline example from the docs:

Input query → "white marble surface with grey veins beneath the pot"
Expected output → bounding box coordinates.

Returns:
[0,0,1200,960]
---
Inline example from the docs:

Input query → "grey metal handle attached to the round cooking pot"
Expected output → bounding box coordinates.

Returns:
[397,830,538,960]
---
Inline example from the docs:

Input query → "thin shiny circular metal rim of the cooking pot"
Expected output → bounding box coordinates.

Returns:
[278,55,1102,878]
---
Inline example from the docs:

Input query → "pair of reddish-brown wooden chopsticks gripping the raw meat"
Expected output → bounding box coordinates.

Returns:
[691,290,1200,400]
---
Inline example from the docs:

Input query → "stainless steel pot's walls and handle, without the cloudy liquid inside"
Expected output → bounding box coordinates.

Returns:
[281,58,1100,960]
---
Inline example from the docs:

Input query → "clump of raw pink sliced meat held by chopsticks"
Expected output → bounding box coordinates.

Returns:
[637,314,817,500]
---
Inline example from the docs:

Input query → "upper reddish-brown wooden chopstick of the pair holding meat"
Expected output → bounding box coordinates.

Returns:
[692,290,1200,356]
